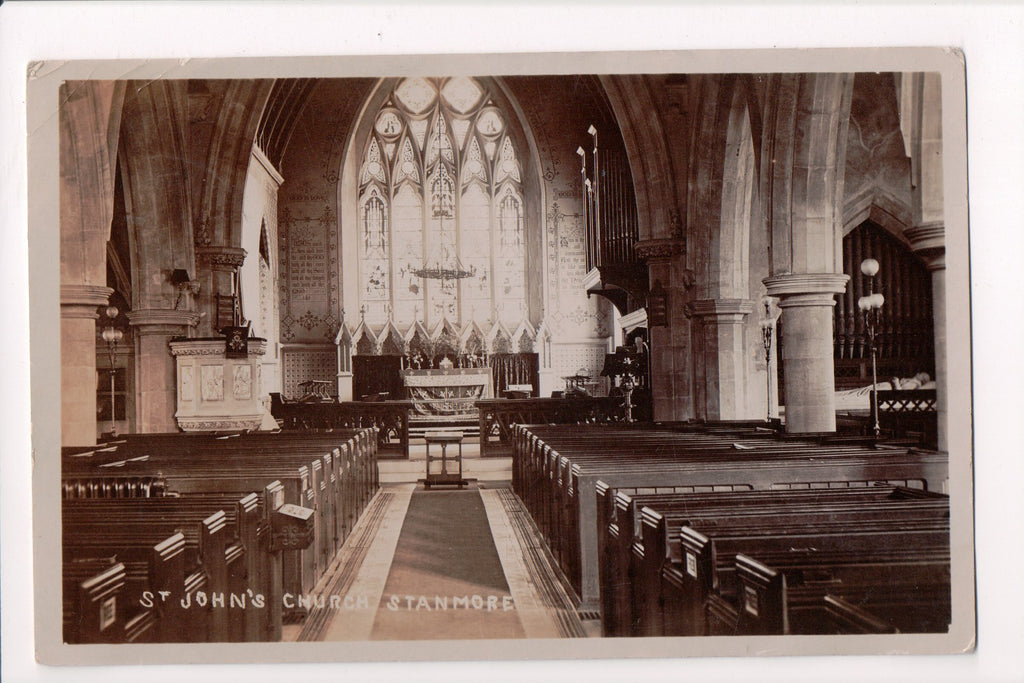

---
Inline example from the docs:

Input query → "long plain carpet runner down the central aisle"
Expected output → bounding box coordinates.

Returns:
[372,489,525,640]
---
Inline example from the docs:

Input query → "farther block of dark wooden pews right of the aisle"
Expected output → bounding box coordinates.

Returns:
[513,425,947,609]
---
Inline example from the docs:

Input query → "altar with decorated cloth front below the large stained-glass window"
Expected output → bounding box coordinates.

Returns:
[401,368,495,419]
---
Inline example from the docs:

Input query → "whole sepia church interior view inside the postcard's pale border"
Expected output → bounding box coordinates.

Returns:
[59,72,951,643]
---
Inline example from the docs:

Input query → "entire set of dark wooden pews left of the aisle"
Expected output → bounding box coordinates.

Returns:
[61,429,379,643]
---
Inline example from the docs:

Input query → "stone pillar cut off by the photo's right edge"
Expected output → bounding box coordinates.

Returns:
[904,223,949,451]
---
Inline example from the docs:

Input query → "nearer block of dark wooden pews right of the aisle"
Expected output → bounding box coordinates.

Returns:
[598,485,950,636]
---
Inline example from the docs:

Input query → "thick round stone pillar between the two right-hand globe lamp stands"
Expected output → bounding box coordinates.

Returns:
[764,273,849,433]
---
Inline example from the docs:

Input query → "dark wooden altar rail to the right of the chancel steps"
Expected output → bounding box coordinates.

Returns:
[476,396,626,458]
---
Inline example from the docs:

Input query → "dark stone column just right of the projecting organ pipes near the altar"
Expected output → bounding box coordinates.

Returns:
[635,239,693,420]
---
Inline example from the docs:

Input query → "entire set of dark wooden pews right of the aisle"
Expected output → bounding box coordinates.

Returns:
[513,423,949,635]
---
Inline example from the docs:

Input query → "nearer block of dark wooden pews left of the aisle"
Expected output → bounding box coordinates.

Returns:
[62,489,282,642]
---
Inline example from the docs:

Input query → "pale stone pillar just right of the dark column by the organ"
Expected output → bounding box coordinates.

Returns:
[687,299,754,420]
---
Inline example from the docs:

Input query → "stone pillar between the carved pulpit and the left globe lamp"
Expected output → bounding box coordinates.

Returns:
[128,308,199,433]
